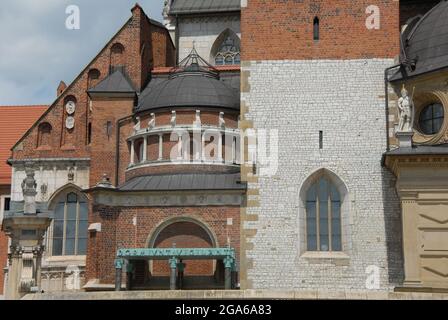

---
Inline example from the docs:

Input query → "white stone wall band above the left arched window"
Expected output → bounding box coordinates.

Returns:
[11,161,89,202]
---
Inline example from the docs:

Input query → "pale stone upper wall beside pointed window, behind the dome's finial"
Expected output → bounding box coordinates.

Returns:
[178,15,241,64]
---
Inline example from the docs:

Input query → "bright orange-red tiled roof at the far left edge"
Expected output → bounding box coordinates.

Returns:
[0,106,48,185]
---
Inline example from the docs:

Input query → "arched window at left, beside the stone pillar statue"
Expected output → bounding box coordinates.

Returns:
[52,192,88,256]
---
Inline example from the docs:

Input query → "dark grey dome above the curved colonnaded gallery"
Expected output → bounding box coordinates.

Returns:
[135,70,240,112]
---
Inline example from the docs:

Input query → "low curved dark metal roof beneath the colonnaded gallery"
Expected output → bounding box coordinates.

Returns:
[119,173,246,191]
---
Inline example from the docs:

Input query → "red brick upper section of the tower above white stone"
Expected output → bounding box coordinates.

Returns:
[241,0,399,61]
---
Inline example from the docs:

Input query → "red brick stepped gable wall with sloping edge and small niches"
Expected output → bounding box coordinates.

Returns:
[13,6,174,159]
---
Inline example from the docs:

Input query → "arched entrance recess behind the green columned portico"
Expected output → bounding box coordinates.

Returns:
[129,217,228,290]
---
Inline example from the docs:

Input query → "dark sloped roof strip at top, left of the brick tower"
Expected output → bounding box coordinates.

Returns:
[170,0,241,14]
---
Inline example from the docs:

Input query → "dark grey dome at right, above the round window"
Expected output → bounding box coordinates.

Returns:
[392,1,448,80]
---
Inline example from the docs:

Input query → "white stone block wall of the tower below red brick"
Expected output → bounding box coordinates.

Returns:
[242,59,402,290]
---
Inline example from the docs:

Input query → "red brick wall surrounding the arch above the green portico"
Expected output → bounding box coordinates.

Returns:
[87,205,240,284]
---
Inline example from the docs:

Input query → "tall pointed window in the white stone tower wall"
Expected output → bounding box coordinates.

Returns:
[306,176,342,251]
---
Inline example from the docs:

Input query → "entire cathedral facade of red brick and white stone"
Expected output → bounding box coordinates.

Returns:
[2,0,448,299]
